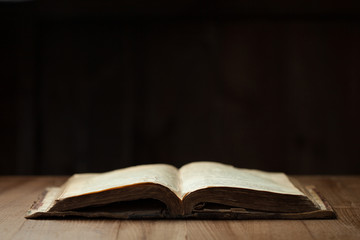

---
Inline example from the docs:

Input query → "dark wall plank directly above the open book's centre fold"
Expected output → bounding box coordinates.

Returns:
[134,21,223,166]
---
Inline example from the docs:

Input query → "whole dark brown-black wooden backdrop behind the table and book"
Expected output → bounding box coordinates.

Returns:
[0,0,360,174]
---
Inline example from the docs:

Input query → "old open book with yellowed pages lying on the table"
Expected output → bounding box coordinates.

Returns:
[26,162,335,219]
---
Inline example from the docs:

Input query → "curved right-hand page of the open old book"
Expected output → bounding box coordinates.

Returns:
[179,162,304,198]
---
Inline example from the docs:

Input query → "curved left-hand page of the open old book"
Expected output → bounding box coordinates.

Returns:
[57,164,180,200]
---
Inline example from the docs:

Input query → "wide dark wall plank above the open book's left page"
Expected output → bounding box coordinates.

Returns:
[38,21,133,174]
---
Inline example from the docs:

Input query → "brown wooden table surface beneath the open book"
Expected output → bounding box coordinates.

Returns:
[0,176,360,240]
